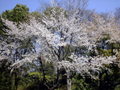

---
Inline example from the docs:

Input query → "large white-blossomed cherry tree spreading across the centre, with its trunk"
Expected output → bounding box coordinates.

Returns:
[1,1,119,90]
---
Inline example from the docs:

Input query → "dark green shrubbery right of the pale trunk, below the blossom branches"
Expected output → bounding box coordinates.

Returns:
[72,64,120,90]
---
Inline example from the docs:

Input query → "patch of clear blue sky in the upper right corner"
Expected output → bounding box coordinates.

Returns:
[87,0,120,13]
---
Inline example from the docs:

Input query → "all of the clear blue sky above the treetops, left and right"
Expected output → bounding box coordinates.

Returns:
[0,0,120,14]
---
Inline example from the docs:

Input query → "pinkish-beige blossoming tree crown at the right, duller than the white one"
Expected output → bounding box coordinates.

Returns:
[88,13,120,43]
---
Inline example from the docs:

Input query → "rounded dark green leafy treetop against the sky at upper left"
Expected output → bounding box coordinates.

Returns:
[2,4,29,24]
